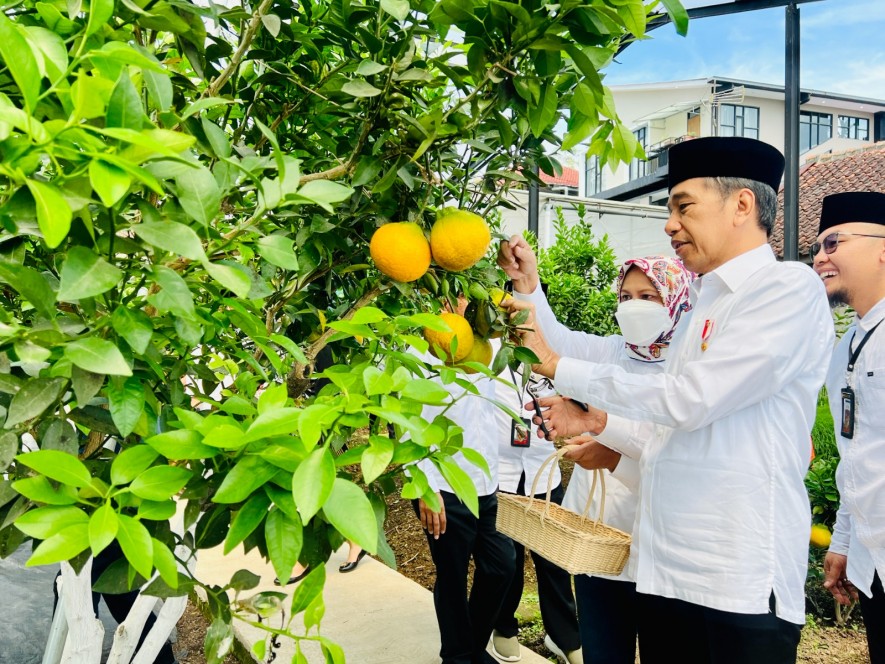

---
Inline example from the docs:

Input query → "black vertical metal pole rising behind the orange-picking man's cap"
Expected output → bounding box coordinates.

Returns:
[784,2,799,261]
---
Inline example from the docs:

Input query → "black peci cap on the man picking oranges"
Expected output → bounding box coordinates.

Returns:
[668,136,784,193]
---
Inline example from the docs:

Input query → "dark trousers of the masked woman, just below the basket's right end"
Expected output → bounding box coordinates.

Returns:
[575,574,636,664]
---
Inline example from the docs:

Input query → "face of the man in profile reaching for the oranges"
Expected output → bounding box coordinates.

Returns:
[664,178,736,274]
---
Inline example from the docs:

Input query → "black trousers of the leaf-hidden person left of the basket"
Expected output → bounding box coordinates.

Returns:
[412,491,515,664]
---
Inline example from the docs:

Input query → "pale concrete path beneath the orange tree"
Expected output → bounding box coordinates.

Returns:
[196,546,547,664]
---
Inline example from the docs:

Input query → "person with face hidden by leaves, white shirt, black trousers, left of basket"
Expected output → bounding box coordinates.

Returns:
[412,320,515,664]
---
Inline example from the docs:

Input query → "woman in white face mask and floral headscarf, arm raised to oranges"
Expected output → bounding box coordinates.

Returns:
[498,248,694,664]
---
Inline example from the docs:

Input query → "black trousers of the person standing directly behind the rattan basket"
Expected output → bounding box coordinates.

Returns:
[495,473,580,652]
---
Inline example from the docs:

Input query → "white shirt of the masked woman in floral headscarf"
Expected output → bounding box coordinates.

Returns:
[514,287,664,581]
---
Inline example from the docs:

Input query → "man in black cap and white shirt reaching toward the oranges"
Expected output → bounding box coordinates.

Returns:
[507,137,834,664]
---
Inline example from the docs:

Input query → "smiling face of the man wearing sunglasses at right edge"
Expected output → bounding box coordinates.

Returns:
[811,222,885,306]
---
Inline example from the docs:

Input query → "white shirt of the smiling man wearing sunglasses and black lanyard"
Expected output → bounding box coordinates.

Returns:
[827,300,885,597]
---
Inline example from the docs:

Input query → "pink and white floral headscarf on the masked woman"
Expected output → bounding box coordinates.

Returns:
[617,256,696,362]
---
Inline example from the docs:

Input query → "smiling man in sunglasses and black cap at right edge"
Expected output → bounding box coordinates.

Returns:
[811,192,885,664]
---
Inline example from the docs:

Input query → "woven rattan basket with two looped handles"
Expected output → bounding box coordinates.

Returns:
[496,447,630,576]
